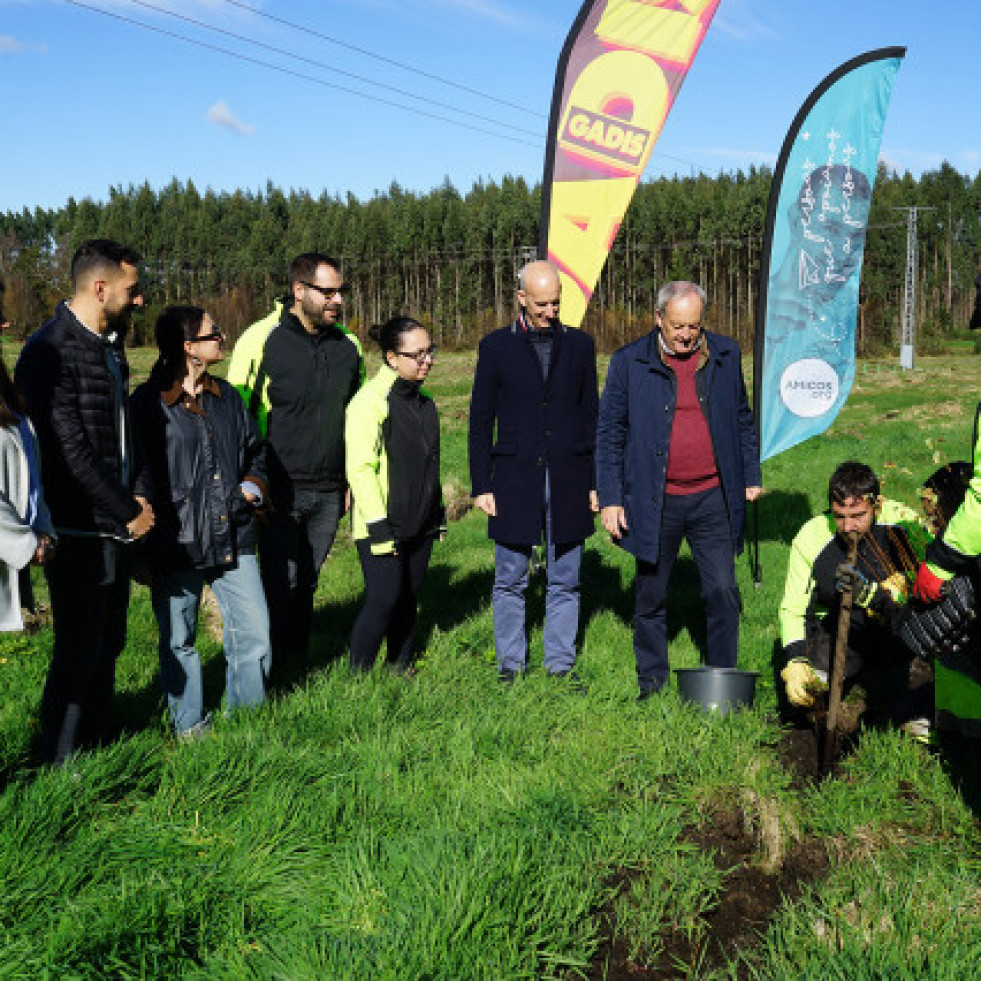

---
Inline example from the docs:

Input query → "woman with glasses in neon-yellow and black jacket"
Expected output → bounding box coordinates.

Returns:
[344,317,446,673]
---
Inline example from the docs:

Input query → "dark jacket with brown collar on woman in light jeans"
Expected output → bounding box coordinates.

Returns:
[130,375,266,570]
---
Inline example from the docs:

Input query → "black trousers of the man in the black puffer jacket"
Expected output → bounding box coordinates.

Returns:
[41,535,130,763]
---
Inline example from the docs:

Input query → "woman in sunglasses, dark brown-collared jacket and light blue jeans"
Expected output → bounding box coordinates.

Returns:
[131,306,271,738]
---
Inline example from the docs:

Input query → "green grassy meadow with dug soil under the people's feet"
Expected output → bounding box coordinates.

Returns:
[0,340,981,981]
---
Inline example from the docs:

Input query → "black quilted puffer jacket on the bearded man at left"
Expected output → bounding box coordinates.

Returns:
[14,303,140,539]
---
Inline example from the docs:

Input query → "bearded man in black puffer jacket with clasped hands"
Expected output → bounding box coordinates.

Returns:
[15,239,153,764]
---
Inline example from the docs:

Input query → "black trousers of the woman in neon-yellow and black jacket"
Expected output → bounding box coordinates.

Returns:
[351,536,433,671]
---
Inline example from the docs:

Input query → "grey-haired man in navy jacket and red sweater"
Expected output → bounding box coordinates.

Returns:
[596,282,762,700]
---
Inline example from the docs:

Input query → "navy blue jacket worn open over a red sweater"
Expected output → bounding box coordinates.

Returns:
[596,330,763,563]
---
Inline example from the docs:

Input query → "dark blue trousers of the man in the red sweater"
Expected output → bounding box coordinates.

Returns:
[634,487,742,690]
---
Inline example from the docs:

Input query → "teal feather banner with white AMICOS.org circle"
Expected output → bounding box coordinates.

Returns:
[753,48,906,460]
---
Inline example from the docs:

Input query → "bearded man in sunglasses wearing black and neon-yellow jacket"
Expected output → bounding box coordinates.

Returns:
[228,252,363,677]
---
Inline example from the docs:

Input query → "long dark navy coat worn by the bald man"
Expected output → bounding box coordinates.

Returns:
[470,320,598,545]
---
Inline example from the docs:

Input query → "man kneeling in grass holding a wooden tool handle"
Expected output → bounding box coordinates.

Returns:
[780,461,933,737]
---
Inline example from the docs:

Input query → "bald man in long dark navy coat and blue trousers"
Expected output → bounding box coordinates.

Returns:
[470,261,599,682]
